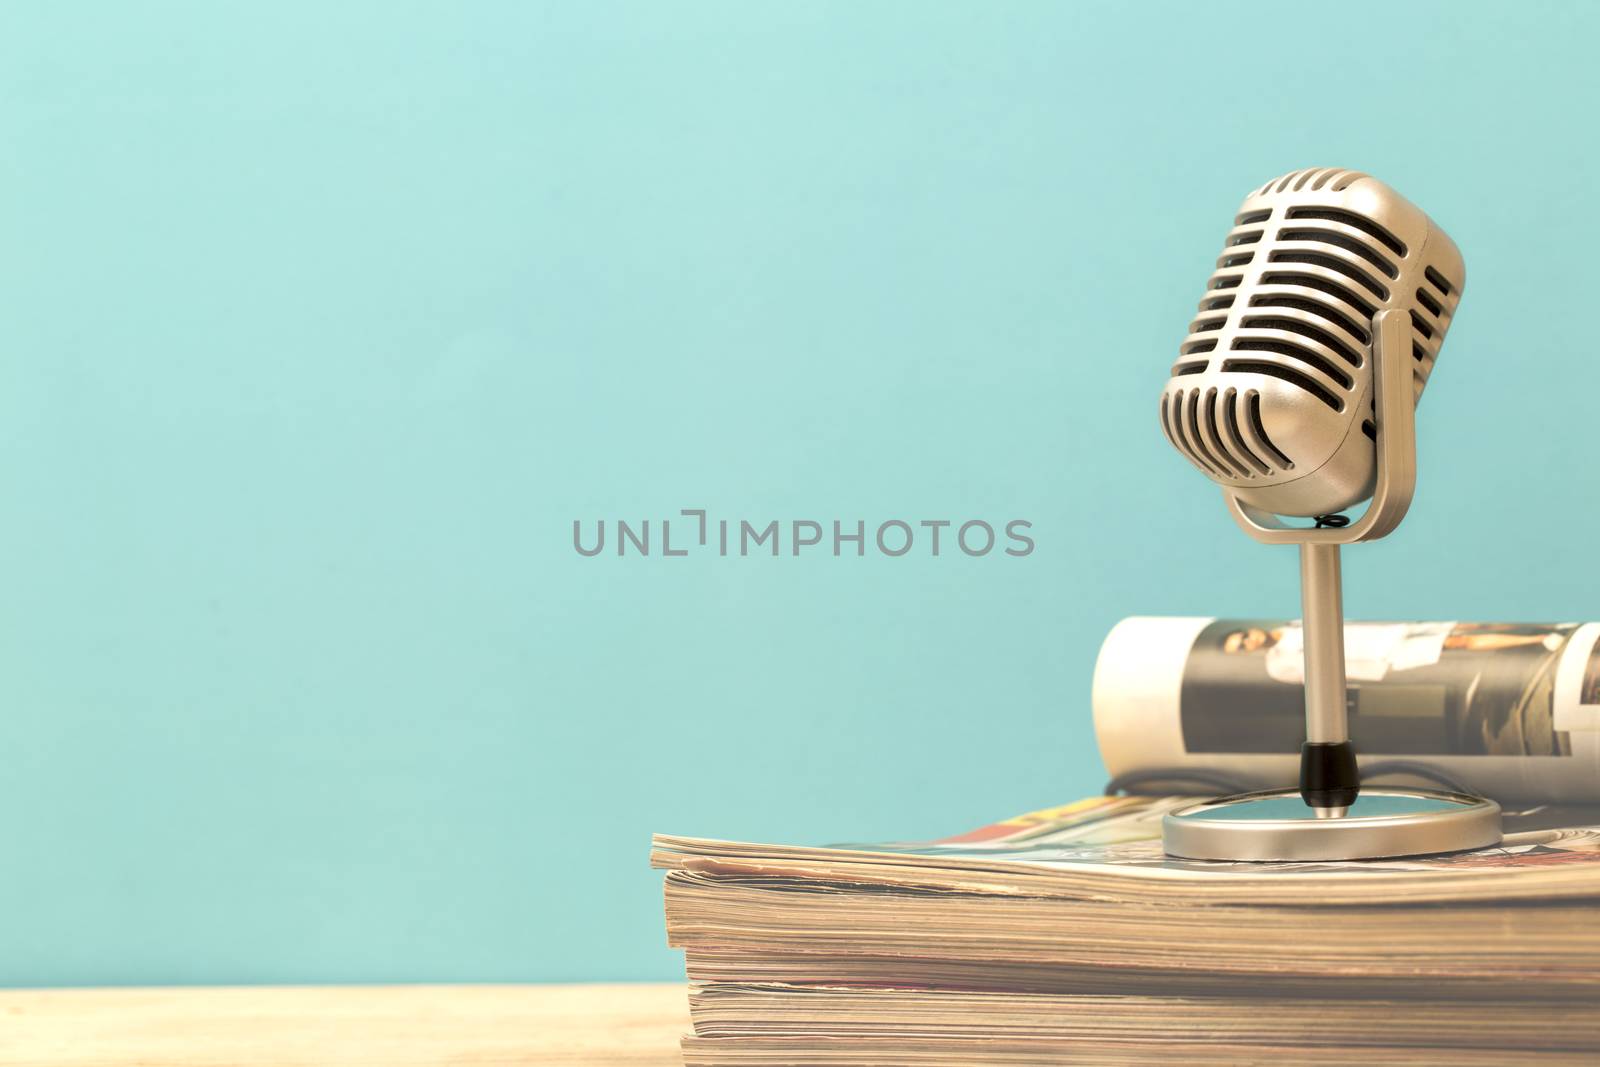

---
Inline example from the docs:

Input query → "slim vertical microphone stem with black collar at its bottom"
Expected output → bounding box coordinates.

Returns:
[1299,542,1360,817]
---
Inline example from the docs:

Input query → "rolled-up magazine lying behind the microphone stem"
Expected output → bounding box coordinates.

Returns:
[1093,616,1600,805]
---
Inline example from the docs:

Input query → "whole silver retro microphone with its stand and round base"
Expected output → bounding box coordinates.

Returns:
[1160,168,1501,859]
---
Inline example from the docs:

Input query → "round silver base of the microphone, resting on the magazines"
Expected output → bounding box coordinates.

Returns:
[1162,787,1501,862]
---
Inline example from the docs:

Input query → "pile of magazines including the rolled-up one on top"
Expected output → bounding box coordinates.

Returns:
[653,619,1600,1067]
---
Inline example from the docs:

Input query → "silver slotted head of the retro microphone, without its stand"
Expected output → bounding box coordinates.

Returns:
[1162,168,1466,517]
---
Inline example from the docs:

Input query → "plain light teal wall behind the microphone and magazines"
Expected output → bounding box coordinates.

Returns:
[0,2,1600,985]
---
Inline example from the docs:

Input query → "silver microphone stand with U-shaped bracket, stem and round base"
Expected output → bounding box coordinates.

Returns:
[1163,309,1501,861]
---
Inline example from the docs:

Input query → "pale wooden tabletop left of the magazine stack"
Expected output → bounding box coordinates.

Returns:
[0,984,688,1067]
